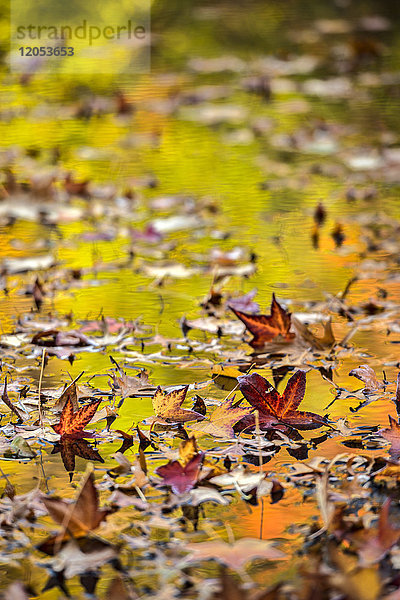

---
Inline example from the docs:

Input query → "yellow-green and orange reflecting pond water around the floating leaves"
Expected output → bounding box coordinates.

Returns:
[0,1,400,598]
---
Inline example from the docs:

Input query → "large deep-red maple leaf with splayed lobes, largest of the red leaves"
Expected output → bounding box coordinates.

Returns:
[238,371,325,429]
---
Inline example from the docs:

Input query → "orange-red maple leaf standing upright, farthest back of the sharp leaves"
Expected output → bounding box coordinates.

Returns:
[230,294,295,349]
